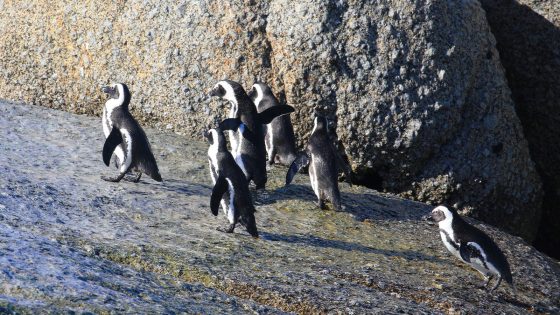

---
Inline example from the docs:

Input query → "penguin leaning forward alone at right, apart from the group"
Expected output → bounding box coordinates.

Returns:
[427,206,515,292]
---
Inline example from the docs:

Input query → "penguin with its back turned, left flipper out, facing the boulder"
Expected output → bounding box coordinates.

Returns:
[286,116,350,211]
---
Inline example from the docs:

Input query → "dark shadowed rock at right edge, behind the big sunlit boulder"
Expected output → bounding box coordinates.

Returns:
[481,0,560,259]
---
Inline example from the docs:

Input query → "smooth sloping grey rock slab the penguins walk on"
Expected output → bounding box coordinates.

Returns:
[0,103,560,314]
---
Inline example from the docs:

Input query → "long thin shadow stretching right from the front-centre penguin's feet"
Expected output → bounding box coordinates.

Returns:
[260,232,445,263]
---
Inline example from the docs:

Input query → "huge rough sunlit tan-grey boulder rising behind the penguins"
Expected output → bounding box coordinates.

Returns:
[0,0,542,239]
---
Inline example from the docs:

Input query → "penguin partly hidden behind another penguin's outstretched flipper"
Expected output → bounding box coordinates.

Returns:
[249,82,297,166]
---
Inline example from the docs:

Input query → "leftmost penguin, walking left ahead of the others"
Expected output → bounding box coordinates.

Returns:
[101,83,162,182]
